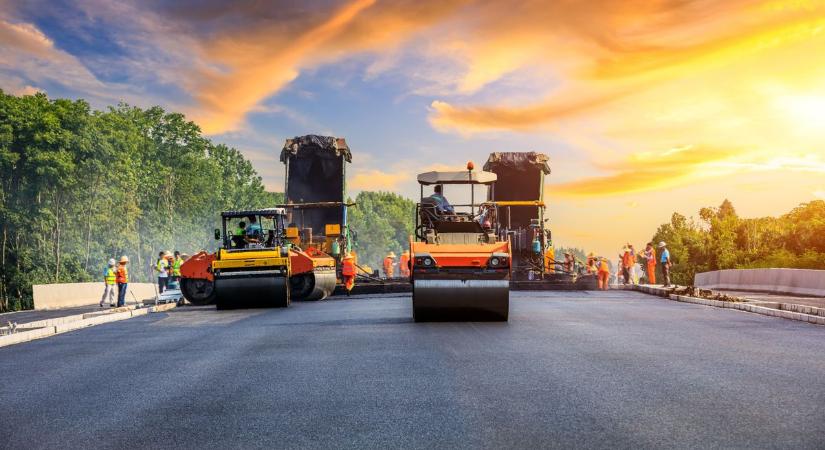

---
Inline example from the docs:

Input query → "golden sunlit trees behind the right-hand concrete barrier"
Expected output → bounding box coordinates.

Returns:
[652,200,825,284]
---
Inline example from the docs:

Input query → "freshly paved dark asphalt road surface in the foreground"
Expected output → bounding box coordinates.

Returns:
[0,291,825,449]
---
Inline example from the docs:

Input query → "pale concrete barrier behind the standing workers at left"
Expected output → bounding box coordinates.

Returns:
[32,281,156,309]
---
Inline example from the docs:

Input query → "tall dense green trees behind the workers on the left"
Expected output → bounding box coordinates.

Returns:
[0,91,281,311]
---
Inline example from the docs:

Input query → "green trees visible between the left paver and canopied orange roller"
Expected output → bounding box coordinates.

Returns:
[348,191,415,268]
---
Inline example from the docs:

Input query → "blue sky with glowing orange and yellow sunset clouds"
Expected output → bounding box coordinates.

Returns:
[0,0,825,256]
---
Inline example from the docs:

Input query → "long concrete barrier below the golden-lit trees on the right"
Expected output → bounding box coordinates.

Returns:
[693,269,825,297]
